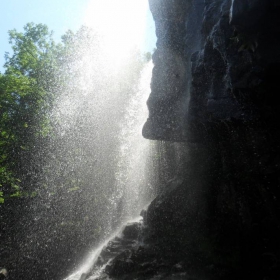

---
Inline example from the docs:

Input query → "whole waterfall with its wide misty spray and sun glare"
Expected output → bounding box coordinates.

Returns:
[0,0,159,279]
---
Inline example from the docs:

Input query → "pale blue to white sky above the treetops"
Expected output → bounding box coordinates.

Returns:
[0,0,156,72]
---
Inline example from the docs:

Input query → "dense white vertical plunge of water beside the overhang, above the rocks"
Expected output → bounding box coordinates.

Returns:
[112,62,153,222]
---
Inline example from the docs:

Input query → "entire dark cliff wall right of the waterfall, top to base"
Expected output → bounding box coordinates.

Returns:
[104,0,280,280]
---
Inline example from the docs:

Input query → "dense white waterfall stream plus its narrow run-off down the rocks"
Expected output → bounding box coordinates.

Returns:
[62,62,153,280]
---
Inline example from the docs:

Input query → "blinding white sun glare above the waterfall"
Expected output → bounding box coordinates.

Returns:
[85,0,148,67]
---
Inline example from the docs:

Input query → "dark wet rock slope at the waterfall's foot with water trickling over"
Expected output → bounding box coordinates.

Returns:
[84,222,192,280]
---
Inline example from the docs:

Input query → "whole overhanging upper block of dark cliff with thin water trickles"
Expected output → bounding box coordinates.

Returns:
[143,0,280,141]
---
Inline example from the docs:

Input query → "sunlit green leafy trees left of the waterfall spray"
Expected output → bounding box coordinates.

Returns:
[0,23,61,197]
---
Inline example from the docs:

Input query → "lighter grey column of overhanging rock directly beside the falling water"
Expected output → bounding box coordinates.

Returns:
[143,0,198,140]
